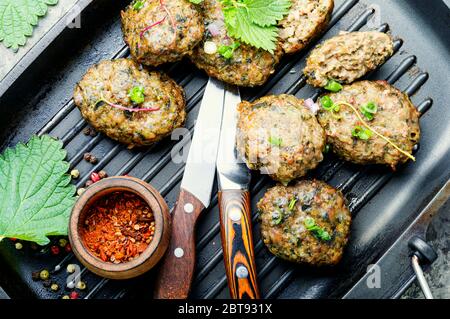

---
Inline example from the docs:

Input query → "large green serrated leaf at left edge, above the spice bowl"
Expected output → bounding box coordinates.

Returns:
[0,136,75,245]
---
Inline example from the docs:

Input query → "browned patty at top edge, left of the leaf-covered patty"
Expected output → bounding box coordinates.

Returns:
[122,0,205,66]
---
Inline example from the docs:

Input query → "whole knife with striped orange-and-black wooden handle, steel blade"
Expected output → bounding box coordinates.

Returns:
[217,86,260,299]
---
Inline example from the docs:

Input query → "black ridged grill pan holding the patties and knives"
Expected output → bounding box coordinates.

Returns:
[0,0,450,299]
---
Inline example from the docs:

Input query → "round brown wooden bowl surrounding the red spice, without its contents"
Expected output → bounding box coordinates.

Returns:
[69,176,171,279]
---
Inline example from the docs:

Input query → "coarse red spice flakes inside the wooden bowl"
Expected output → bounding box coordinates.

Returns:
[80,192,155,264]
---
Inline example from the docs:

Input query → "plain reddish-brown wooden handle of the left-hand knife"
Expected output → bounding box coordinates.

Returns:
[154,189,205,299]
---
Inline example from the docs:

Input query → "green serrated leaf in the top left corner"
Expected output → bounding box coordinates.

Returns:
[0,0,58,51]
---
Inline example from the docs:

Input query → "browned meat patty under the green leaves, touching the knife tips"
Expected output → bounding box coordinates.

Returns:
[190,0,282,86]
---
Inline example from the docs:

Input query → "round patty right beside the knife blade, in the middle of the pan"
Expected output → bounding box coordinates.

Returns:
[236,94,325,184]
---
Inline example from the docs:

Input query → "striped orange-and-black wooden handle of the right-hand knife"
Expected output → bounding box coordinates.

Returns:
[219,190,260,299]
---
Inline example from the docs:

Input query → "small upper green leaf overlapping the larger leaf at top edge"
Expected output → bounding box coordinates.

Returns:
[244,0,291,27]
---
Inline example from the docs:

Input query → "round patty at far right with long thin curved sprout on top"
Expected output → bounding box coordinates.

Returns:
[318,81,420,168]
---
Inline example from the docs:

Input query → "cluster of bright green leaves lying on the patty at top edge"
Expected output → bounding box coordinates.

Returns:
[220,0,291,53]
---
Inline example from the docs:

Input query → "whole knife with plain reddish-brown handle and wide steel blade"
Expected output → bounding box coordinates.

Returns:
[154,78,225,299]
